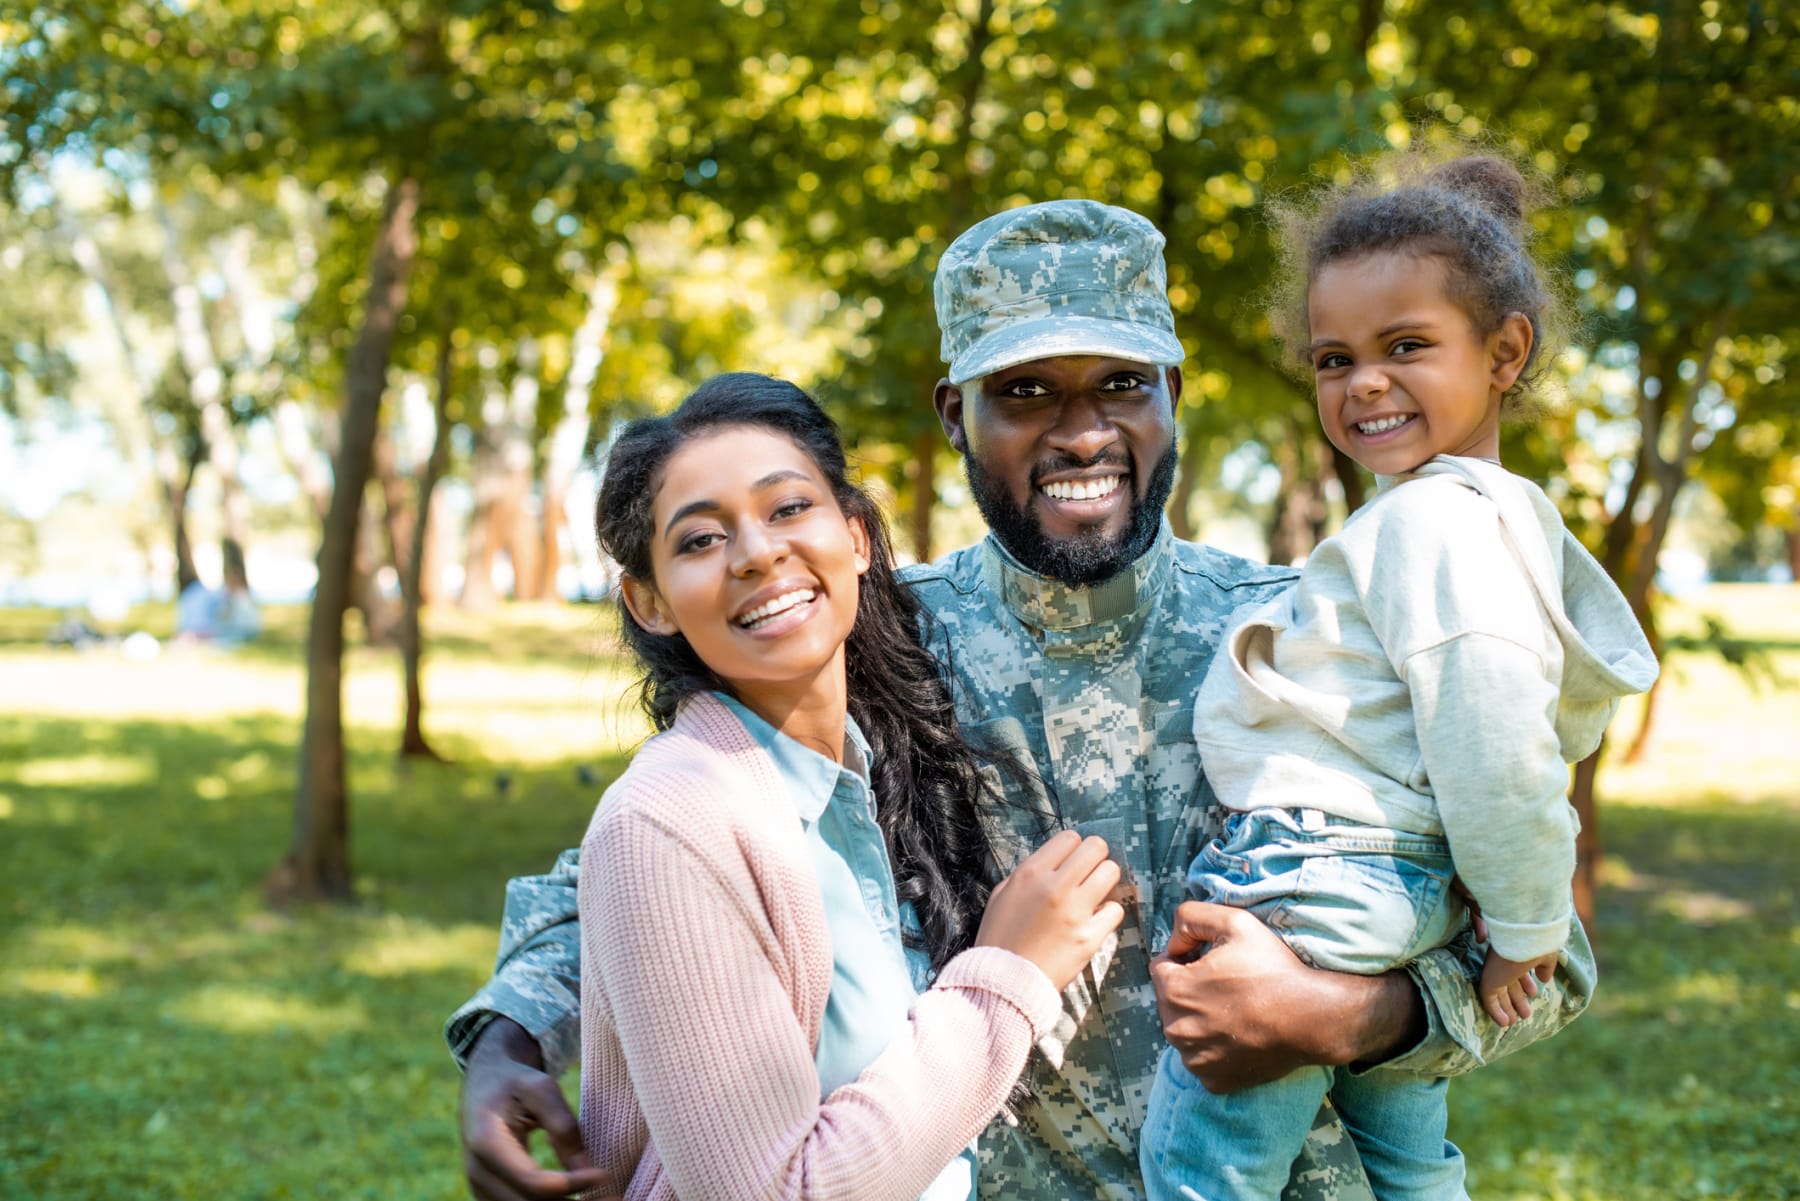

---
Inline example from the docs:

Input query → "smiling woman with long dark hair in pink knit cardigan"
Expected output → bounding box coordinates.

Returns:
[580,375,1123,1201]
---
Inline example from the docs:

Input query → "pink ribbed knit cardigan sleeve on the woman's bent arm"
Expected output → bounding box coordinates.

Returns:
[580,814,1060,1201]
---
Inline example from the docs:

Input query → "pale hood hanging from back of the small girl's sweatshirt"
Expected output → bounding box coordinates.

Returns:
[1415,456,1658,763]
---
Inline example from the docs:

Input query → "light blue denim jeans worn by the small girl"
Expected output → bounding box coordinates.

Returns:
[1138,808,1467,1201]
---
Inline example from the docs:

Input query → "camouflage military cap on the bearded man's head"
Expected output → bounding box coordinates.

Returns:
[932,200,1184,384]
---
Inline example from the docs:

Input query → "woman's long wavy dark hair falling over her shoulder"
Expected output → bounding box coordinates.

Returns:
[594,373,990,969]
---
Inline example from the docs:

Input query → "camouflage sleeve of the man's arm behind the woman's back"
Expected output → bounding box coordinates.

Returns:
[445,850,581,1075]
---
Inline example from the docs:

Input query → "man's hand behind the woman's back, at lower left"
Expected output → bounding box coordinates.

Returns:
[461,1017,608,1201]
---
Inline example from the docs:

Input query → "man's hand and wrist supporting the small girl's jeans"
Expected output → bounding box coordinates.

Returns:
[1150,900,1424,1093]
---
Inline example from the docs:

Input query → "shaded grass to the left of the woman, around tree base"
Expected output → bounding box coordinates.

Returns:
[0,717,623,1201]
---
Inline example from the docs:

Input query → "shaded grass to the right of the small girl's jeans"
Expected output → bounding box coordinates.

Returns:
[1451,798,1800,1197]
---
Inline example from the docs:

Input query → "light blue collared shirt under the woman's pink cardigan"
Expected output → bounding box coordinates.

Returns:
[715,693,976,1201]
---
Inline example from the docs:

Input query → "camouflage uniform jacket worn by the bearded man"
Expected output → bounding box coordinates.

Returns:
[446,524,1593,1201]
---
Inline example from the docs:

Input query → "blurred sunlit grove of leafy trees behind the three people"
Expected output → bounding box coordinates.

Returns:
[0,0,1800,906]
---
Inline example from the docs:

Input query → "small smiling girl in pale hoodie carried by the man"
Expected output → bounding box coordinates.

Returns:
[1139,157,1656,1201]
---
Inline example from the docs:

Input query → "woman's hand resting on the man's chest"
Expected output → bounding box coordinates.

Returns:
[976,830,1125,990]
